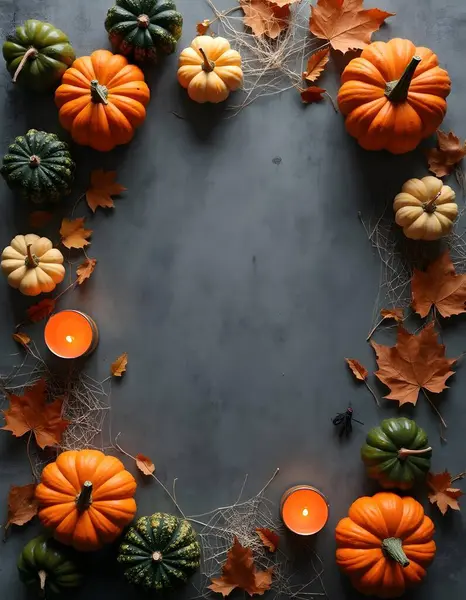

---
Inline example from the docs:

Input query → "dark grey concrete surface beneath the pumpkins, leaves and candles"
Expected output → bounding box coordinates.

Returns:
[0,0,466,600]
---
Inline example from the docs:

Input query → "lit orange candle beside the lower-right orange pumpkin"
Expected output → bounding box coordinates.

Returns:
[280,485,328,535]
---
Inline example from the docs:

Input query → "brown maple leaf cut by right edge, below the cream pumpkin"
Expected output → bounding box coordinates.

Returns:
[411,250,466,318]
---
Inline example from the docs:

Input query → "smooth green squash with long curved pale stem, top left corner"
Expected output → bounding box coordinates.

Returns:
[3,19,76,92]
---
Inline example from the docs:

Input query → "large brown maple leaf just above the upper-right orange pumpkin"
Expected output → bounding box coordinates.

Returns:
[309,0,395,54]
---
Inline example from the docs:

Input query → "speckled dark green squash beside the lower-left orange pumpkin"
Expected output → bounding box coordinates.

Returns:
[118,513,201,591]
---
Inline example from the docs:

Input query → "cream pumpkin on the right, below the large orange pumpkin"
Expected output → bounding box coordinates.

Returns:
[393,176,458,240]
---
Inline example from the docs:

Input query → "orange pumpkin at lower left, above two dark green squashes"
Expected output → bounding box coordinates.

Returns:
[36,450,136,551]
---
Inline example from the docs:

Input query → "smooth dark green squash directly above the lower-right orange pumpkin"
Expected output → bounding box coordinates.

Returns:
[361,417,432,490]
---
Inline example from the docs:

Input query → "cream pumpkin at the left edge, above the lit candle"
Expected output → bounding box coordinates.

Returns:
[1,233,65,296]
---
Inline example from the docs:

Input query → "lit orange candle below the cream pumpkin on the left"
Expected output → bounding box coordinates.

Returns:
[45,310,99,358]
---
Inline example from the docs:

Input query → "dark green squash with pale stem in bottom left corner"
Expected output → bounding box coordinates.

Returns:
[18,535,82,599]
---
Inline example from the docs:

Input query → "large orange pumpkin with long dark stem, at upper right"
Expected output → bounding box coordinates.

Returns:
[338,39,451,154]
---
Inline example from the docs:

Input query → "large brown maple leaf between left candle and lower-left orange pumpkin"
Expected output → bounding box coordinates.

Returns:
[1,379,70,449]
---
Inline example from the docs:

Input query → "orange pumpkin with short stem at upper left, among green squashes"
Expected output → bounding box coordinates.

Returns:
[55,50,150,152]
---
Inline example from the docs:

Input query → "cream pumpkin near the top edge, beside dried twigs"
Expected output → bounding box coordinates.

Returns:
[178,35,243,104]
